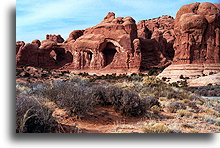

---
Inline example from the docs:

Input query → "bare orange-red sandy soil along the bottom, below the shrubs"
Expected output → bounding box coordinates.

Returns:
[49,103,220,133]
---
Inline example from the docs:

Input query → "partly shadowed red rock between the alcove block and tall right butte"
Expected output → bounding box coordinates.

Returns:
[137,15,175,69]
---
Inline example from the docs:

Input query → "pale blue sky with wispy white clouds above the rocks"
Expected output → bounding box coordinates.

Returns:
[16,0,220,43]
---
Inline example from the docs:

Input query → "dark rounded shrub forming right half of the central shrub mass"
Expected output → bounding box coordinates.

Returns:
[94,86,146,116]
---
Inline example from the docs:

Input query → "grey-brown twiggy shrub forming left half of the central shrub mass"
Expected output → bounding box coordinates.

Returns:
[42,82,96,116]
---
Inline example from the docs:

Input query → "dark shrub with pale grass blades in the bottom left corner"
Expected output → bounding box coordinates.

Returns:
[16,96,58,133]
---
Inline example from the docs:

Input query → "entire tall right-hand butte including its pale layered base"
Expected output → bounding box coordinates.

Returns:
[159,2,220,85]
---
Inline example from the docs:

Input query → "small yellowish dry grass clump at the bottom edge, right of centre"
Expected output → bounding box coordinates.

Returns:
[143,123,173,133]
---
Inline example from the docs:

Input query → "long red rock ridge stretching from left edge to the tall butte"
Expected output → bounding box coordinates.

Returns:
[16,12,174,73]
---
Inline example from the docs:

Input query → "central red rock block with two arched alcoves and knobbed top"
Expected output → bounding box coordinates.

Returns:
[66,13,139,70]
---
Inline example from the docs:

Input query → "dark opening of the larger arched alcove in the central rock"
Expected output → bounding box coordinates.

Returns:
[102,42,117,67]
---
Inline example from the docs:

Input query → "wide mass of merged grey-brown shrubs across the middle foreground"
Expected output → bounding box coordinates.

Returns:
[33,79,146,116]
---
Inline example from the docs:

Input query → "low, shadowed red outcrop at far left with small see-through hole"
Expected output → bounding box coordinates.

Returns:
[16,39,71,68]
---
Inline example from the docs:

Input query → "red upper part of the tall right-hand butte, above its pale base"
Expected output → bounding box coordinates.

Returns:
[174,2,220,64]
